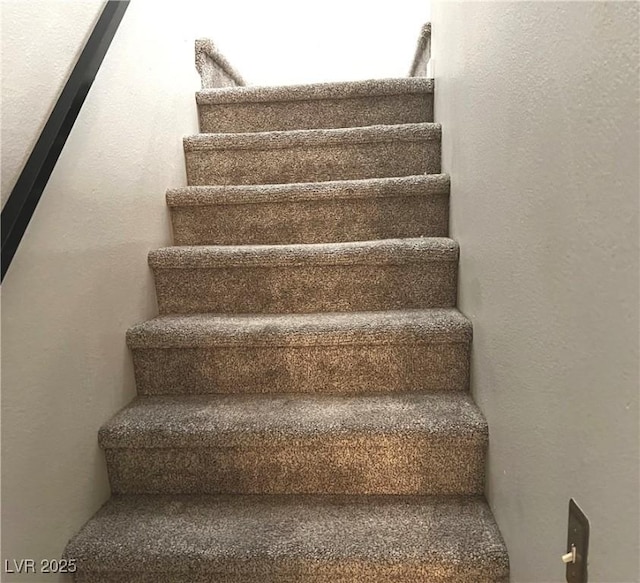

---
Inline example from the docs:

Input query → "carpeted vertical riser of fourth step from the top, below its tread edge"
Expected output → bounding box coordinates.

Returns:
[154,260,457,314]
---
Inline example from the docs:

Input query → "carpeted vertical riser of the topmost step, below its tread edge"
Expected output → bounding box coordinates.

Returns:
[198,93,433,133]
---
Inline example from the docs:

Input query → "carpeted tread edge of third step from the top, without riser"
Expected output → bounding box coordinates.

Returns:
[167,174,449,207]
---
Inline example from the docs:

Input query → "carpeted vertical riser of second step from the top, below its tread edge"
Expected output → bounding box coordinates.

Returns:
[185,139,440,185]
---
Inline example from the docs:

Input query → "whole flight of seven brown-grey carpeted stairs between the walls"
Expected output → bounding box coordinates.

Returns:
[65,51,508,583]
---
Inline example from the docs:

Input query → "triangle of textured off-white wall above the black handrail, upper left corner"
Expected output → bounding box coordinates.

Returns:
[0,0,102,206]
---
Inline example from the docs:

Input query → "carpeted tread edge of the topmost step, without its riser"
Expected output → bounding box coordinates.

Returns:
[196,77,434,105]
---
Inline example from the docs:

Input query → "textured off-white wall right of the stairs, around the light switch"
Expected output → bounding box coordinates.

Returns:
[432,1,640,583]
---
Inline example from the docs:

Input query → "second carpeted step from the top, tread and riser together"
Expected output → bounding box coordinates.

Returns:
[184,123,440,186]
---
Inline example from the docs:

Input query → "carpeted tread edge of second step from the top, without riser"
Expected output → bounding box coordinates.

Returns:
[183,122,441,152]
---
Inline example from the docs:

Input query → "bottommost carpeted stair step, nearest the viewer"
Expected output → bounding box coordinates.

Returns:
[65,496,509,583]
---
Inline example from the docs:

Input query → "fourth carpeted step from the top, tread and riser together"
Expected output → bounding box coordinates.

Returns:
[149,238,458,314]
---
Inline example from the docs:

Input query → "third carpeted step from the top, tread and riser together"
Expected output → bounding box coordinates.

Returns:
[167,174,449,245]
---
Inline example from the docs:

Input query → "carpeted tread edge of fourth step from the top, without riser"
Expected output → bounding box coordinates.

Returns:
[149,237,458,269]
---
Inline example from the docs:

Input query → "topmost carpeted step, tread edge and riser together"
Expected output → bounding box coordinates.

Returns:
[196,77,433,133]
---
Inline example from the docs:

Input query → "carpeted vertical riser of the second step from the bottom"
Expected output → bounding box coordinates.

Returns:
[106,434,485,495]
